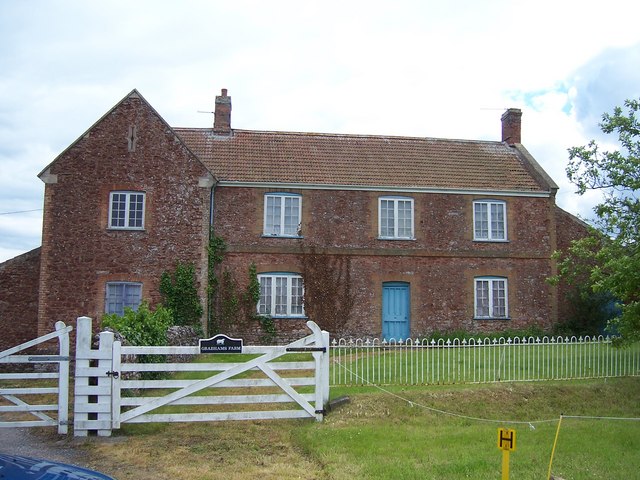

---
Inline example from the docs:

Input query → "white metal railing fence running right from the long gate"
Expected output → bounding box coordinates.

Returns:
[331,336,640,386]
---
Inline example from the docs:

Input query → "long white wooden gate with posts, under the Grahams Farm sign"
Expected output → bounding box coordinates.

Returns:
[74,317,329,436]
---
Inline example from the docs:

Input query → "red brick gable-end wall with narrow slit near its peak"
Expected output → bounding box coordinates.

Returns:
[38,96,210,338]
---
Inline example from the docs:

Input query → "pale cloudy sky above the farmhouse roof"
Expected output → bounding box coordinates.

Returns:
[0,0,640,262]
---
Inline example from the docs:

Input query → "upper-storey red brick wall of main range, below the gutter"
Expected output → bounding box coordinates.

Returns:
[215,187,555,258]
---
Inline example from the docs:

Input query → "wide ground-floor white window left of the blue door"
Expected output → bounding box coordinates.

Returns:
[258,273,304,317]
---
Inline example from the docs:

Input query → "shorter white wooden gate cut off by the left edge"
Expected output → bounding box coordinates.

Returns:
[0,322,73,435]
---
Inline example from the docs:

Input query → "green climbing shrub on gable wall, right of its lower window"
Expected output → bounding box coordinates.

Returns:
[160,262,203,328]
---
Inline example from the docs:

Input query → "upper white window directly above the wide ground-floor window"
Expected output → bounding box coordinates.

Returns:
[264,193,302,237]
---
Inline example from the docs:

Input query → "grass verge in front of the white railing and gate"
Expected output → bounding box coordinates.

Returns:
[80,377,640,480]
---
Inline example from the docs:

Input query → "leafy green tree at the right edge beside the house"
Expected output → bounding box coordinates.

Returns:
[558,100,640,344]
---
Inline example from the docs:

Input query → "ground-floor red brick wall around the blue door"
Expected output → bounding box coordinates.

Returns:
[216,254,554,338]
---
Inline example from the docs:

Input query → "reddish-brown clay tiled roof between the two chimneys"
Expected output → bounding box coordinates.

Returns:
[175,128,550,192]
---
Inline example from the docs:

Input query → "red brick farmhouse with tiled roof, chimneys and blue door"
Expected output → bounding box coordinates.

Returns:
[0,90,585,349]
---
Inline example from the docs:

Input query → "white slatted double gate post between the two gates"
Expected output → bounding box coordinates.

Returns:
[73,317,113,437]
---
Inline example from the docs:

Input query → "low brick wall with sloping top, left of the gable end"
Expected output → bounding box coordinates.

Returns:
[0,248,40,351]
